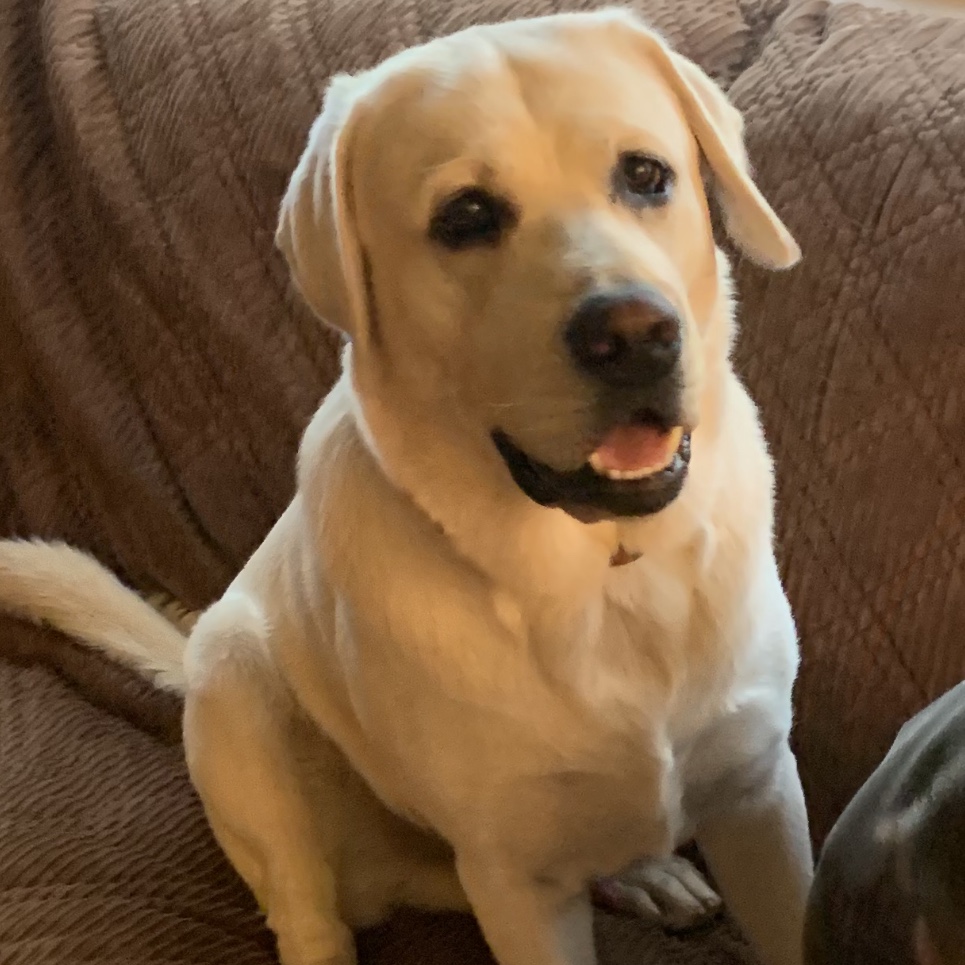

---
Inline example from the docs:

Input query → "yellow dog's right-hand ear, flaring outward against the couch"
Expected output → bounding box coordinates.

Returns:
[617,11,801,268]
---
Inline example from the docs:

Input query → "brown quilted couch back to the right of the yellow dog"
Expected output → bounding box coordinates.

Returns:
[731,0,965,840]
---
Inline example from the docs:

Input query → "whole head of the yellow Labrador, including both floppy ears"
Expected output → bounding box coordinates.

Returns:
[279,11,797,518]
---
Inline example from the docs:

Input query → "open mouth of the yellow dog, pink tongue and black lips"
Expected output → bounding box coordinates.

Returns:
[492,413,690,521]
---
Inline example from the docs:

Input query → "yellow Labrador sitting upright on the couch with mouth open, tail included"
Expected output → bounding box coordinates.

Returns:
[0,9,813,965]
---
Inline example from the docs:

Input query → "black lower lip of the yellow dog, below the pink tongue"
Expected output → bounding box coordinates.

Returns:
[492,429,690,519]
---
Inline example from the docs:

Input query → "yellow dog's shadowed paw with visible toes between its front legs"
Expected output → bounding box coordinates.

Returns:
[593,855,722,931]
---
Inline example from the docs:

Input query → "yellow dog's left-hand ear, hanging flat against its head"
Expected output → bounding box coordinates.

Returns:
[275,75,370,344]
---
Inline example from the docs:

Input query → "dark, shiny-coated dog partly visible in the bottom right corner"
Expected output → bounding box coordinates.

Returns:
[805,683,965,965]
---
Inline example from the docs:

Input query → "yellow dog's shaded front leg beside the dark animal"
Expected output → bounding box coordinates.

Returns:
[697,742,814,965]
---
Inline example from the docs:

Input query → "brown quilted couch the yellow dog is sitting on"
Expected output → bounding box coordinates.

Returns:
[0,0,965,965]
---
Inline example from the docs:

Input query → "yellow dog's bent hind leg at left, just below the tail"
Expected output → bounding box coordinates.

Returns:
[184,602,355,965]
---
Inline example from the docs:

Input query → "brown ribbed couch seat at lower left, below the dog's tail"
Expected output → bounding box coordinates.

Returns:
[0,623,273,965]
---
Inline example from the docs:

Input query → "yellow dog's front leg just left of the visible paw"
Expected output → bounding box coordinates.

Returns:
[457,854,596,965]
